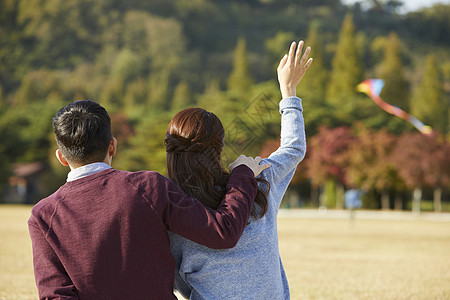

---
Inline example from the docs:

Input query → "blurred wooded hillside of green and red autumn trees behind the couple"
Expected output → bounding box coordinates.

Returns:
[0,0,450,210]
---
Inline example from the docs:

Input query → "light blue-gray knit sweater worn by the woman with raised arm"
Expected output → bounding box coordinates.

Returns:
[169,97,306,300]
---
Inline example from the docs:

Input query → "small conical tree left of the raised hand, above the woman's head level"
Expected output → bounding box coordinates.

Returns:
[227,38,253,95]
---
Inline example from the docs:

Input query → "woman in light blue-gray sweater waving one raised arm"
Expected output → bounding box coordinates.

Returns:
[165,41,312,299]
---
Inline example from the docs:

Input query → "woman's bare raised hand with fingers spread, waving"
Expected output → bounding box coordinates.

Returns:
[277,41,313,98]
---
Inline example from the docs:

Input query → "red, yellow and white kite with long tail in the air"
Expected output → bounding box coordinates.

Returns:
[356,79,433,135]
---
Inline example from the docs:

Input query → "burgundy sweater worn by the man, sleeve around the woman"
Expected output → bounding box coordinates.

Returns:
[28,166,257,300]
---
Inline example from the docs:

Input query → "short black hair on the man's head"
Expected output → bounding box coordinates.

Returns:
[52,100,112,165]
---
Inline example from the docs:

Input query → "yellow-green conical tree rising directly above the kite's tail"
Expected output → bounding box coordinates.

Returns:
[378,33,409,111]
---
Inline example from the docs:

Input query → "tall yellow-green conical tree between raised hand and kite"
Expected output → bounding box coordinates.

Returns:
[327,14,364,104]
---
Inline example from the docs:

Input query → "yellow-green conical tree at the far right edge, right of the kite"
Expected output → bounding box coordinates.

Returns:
[411,54,449,133]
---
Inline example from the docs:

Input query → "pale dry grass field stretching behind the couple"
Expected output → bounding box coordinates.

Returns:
[0,205,450,300]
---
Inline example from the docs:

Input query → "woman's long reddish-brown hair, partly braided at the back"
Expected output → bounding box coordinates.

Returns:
[164,108,270,219]
